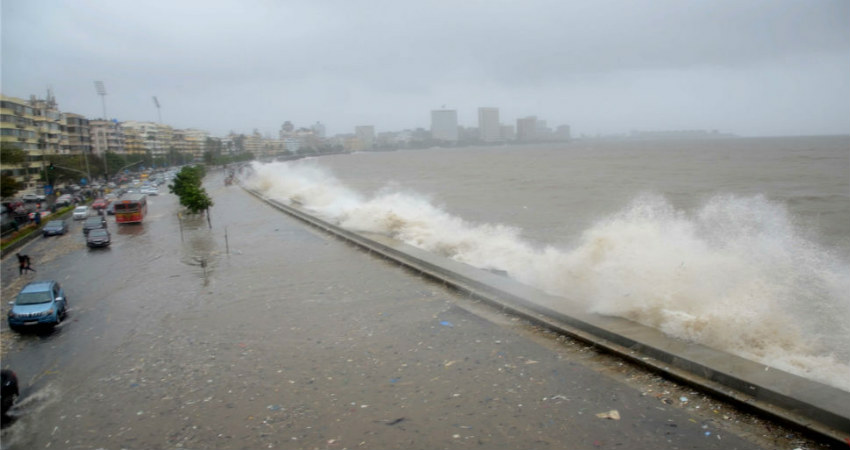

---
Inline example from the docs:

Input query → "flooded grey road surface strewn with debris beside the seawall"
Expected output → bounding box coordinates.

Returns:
[0,174,830,449]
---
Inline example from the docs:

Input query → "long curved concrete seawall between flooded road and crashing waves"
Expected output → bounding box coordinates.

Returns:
[248,186,850,444]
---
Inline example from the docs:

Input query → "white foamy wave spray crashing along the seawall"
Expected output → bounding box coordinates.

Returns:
[238,161,850,391]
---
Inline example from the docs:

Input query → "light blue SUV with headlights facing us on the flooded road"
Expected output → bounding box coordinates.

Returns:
[9,280,68,331]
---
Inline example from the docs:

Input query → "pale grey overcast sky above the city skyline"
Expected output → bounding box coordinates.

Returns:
[2,0,850,136]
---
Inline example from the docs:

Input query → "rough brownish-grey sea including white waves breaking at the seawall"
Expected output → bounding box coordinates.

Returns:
[243,136,850,391]
